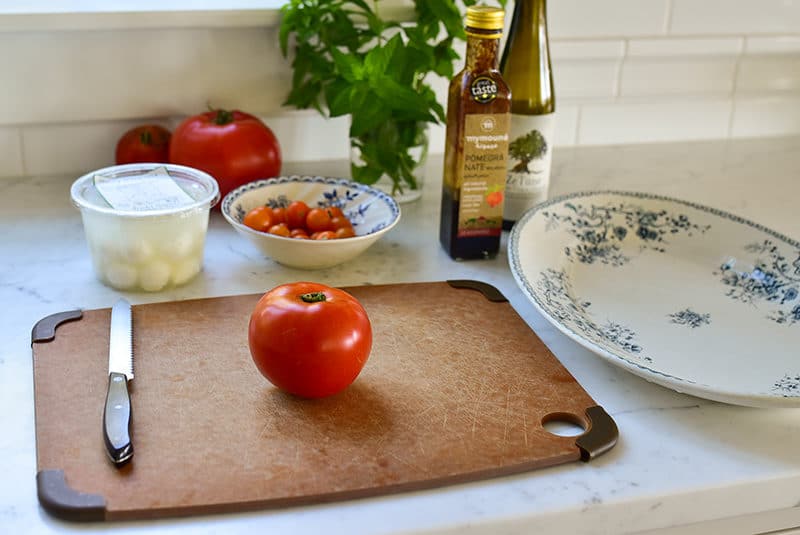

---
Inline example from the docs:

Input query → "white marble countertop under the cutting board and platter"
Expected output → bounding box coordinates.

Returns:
[0,138,800,535]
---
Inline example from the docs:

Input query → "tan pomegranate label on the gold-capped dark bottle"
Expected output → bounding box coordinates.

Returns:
[457,114,510,238]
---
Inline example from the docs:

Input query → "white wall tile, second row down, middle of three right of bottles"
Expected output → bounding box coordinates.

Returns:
[620,56,736,97]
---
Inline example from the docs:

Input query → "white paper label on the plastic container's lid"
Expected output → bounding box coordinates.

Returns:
[94,167,195,212]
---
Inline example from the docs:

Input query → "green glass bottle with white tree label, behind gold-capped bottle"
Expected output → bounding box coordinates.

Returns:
[500,0,556,230]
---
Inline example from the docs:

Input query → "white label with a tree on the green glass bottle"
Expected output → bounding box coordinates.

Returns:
[503,113,555,221]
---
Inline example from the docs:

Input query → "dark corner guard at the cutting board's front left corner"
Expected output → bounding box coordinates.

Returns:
[36,470,106,522]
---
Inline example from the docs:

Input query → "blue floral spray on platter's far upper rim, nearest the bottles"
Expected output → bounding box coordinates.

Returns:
[542,202,710,266]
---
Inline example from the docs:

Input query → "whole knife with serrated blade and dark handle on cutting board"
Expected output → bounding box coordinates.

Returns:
[103,299,133,466]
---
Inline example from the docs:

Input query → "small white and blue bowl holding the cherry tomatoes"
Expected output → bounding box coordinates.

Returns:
[221,175,400,269]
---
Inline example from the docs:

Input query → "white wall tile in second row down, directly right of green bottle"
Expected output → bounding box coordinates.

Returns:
[552,59,620,100]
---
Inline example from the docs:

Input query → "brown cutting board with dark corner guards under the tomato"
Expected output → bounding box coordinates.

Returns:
[32,281,617,520]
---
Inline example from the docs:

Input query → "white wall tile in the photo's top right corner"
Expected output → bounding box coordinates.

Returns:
[669,0,800,35]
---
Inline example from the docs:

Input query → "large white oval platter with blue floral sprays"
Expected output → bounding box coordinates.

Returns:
[508,191,800,407]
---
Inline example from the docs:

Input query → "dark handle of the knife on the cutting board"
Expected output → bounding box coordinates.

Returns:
[103,372,133,465]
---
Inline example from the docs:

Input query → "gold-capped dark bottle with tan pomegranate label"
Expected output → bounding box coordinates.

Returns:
[439,6,511,259]
